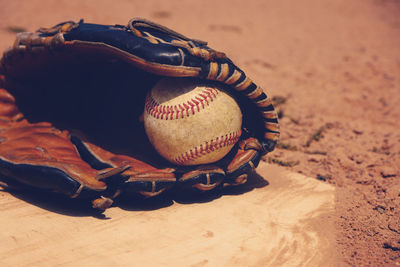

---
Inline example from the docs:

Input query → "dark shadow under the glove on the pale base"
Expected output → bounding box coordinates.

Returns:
[0,173,269,219]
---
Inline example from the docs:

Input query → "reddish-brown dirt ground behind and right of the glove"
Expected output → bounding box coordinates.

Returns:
[0,0,400,266]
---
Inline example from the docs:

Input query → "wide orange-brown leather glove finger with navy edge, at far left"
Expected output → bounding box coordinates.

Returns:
[0,121,107,197]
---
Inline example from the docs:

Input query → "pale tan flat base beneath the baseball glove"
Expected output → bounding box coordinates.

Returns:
[0,164,335,266]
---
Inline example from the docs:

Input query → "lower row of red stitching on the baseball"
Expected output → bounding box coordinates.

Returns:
[175,130,242,165]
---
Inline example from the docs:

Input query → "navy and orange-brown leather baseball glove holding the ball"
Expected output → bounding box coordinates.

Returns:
[0,19,279,210]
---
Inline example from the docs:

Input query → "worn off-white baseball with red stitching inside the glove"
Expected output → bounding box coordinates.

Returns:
[144,78,242,165]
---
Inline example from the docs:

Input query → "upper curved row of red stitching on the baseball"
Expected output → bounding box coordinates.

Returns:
[145,87,219,120]
